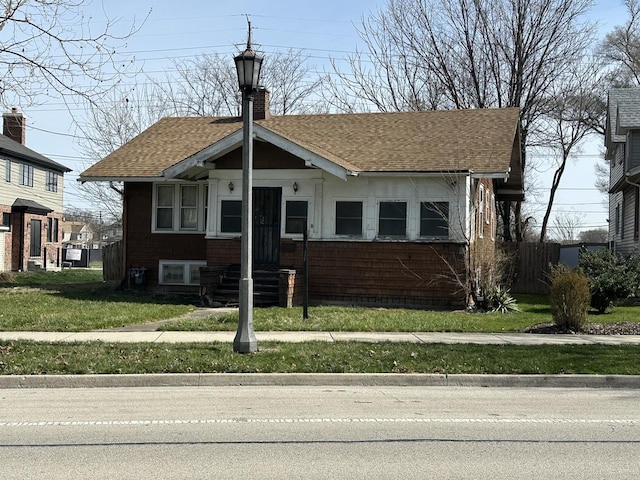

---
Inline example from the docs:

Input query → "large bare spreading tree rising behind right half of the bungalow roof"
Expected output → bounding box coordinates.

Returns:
[326,0,594,240]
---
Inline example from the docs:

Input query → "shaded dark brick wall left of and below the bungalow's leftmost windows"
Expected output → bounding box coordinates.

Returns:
[123,183,206,286]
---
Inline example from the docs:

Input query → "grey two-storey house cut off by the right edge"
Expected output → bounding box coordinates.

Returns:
[605,88,640,255]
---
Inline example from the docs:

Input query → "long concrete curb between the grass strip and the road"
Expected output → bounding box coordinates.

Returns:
[0,373,640,389]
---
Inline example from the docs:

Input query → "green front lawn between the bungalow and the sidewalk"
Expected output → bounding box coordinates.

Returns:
[0,269,640,332]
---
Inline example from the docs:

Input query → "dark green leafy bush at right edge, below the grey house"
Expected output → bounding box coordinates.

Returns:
[578,248,640,313]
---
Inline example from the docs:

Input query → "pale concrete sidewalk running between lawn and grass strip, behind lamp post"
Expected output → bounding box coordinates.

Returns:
[0,330,640,345]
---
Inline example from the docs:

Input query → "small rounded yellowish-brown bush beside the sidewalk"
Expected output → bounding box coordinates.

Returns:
[549,268,590,332]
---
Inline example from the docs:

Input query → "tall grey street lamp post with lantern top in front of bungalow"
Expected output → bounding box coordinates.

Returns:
[233,23,263,353]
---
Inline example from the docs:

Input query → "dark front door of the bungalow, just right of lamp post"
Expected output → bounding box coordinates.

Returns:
[253,187,282,269]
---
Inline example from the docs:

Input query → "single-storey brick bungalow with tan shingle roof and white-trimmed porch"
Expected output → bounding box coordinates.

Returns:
[80,90,523,306]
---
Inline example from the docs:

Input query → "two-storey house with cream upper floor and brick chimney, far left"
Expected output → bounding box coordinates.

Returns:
[0,108,71,271]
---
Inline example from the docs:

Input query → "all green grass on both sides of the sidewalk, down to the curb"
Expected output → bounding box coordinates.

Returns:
[0,269,640,375]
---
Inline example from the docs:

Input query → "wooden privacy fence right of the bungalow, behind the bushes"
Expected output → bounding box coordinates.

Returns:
[502,242,560,295]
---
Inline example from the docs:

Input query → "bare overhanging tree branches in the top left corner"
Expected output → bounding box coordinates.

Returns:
[0,0,146,105]
